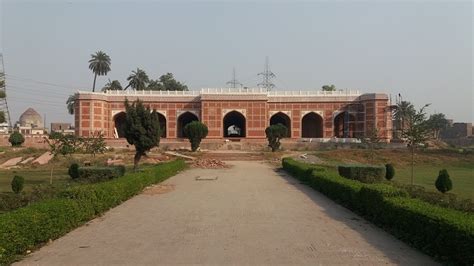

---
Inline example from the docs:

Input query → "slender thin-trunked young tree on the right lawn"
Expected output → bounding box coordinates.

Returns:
[402,104,430,185]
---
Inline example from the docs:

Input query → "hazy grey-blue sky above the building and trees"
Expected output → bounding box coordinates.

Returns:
[0,0,474,125]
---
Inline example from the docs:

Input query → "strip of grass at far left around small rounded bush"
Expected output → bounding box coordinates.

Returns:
[0,168,71,193]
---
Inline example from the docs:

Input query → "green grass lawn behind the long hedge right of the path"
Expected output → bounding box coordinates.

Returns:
[315,149,474,200]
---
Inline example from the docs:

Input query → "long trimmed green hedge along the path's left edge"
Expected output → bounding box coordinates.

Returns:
[0,160,185,265]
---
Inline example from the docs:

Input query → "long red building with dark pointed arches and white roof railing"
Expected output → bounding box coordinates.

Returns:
[75,88,392,140]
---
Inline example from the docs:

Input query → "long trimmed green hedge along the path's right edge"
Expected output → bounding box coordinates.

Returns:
[282,158,474,265]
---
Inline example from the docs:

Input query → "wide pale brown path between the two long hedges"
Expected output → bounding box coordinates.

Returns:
[19,162,435,265]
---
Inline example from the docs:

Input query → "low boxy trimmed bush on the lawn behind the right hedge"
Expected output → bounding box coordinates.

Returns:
[338,165,385,183]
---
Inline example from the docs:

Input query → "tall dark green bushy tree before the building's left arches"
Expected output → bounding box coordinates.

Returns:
[124,100,161,170]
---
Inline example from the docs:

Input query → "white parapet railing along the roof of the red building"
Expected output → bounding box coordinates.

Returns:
[78,87,361,97]
